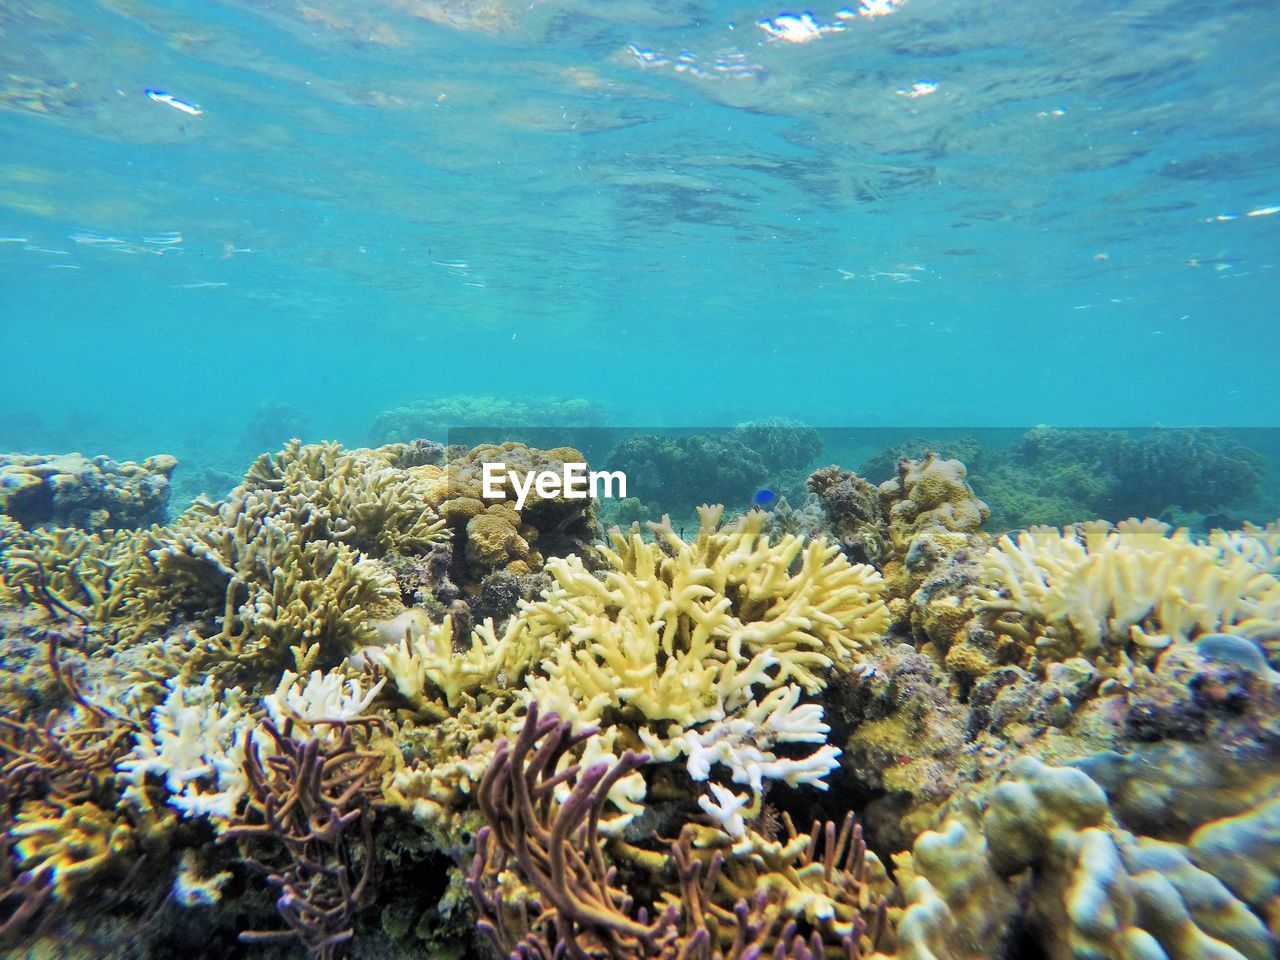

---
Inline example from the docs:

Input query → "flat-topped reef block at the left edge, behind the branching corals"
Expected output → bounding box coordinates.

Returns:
[0,453,178,530]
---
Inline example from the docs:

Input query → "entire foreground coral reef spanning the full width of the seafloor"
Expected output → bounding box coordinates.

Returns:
[0,442,1280,960]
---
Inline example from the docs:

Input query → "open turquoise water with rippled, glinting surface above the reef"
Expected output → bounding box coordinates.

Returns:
[0,0,1280,463]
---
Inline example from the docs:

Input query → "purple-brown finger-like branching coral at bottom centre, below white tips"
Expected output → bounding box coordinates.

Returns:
[467,707,884,960]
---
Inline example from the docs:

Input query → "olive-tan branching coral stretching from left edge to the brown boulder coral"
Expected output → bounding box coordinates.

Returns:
[0,440,447,681]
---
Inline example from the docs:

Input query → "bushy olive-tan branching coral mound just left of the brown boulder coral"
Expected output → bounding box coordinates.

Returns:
[108,442,445,677]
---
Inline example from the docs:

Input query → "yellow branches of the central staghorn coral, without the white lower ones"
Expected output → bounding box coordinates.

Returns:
[374,507,888,727]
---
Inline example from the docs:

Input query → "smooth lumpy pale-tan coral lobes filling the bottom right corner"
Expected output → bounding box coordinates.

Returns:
[908,756,1275,960]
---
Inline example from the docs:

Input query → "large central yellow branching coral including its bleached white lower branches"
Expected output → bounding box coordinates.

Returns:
[520,507,888,832]
